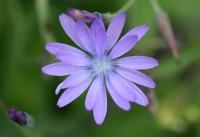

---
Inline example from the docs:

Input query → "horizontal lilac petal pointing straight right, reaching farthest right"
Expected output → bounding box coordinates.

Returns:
[116,56,159,70]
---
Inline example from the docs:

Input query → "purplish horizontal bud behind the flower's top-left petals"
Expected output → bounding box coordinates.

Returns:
[65,8,101,23]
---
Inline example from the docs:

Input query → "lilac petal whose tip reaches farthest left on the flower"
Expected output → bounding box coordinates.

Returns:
[42,62,78,76]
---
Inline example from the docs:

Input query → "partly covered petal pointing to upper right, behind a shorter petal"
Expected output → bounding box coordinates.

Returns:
[122,24,149,41]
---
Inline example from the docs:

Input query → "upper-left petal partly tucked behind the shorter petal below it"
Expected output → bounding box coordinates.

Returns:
[45,42,87,56]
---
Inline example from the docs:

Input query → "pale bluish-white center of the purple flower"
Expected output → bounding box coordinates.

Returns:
[92,56,112,74]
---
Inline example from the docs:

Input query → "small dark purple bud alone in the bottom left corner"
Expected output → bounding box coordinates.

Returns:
[8,108,32,126]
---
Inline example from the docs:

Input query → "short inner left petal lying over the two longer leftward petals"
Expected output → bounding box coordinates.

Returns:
[56,53,92,66]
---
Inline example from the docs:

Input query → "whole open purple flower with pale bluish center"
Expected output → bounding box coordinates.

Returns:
[42,13,158,125]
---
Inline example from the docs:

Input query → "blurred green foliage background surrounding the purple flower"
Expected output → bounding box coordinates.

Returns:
[0,0,200,137]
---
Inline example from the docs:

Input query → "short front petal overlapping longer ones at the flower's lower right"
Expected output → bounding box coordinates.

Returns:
[108,72,135,102]
